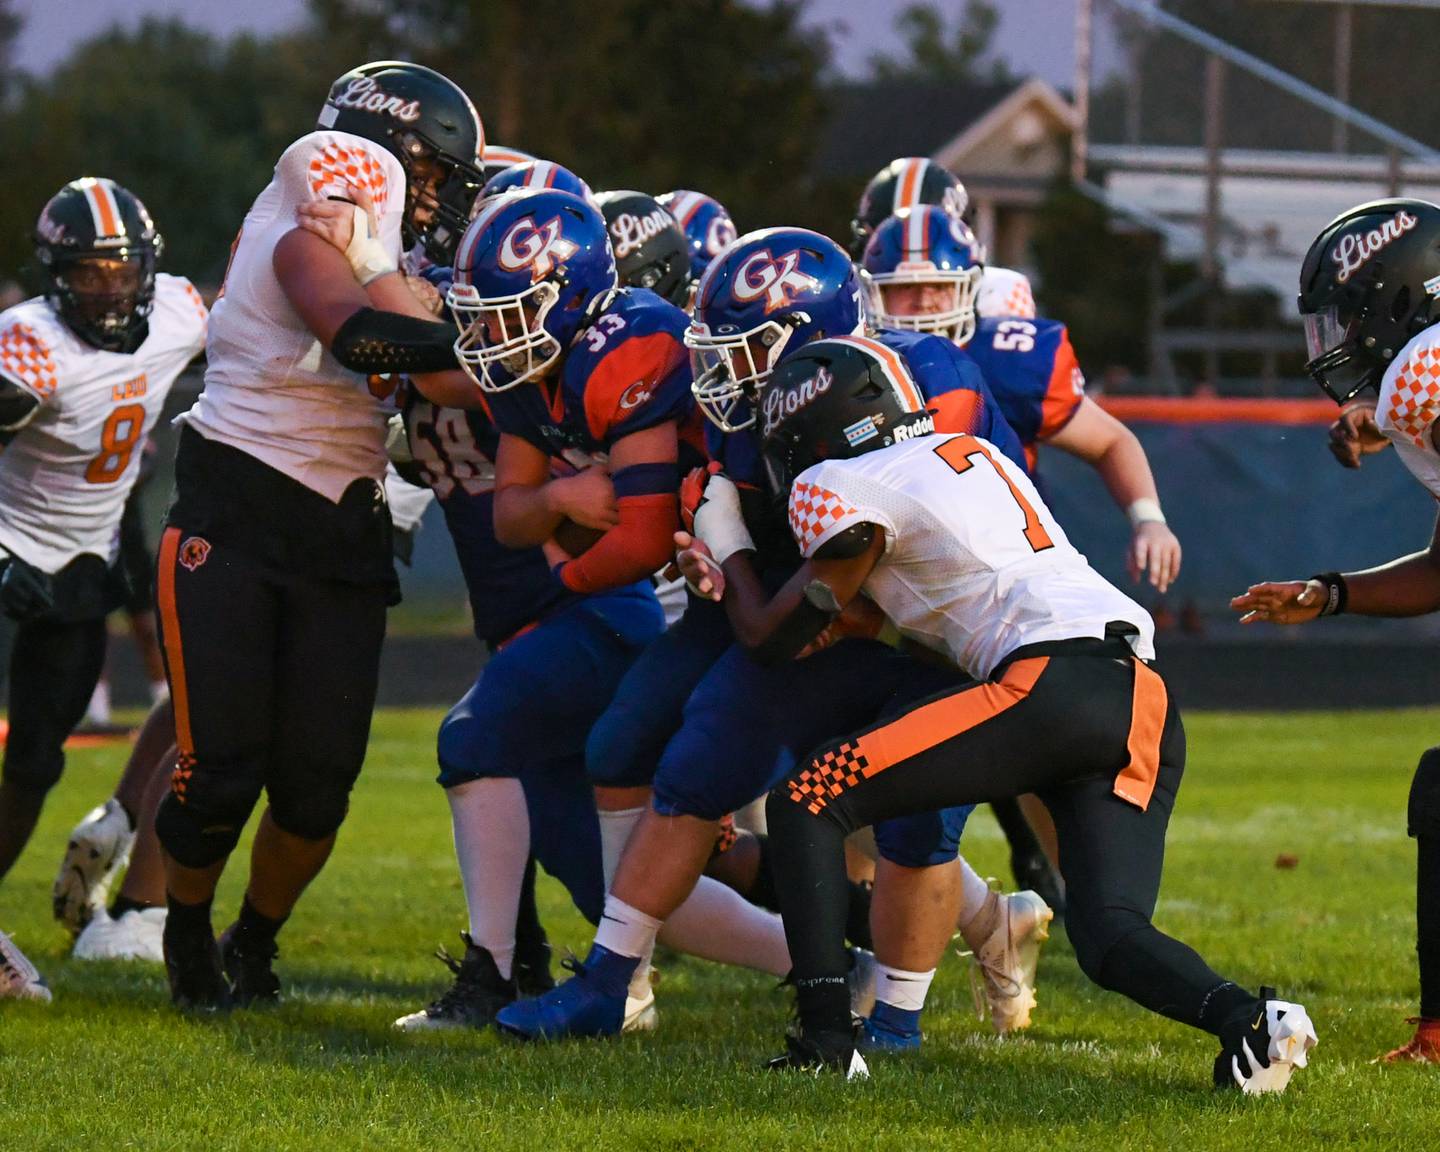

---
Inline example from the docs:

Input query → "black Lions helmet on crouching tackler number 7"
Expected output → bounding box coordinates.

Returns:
[760,336,935,503]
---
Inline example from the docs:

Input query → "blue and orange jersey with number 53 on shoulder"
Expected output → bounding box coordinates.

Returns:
[965,317,1084,469]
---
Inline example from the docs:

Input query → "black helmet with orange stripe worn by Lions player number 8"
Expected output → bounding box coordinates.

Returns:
[35,176,164,353]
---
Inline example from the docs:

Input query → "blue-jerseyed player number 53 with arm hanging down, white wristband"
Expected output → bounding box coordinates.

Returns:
[864,206,1181,592]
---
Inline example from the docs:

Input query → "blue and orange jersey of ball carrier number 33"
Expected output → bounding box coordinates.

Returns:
[490,288,696,462]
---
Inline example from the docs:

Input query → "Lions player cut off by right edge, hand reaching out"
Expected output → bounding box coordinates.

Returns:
[1231,199,1440,1064]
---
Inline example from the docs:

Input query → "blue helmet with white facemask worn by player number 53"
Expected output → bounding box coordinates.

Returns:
[864,204,985,344]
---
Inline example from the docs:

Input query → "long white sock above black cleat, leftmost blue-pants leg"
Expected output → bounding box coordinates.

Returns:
[445,776,530,979]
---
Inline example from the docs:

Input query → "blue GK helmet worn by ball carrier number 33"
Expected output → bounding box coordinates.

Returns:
[445,189,616,392]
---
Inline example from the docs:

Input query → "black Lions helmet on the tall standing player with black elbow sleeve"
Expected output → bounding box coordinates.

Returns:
[317,60,485,265]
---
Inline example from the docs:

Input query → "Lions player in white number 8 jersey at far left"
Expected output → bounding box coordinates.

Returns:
[0,177,207,898]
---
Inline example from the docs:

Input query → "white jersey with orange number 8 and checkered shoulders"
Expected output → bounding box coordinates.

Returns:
[0,272,206,573]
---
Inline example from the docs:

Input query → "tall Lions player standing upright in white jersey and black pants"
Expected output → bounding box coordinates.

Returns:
[156,60,484,1011]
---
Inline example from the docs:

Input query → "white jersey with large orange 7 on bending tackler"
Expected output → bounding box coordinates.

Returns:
[789,435,1155,680]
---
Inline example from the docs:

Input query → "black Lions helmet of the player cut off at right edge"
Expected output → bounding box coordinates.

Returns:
[1299,199,1440,405]
